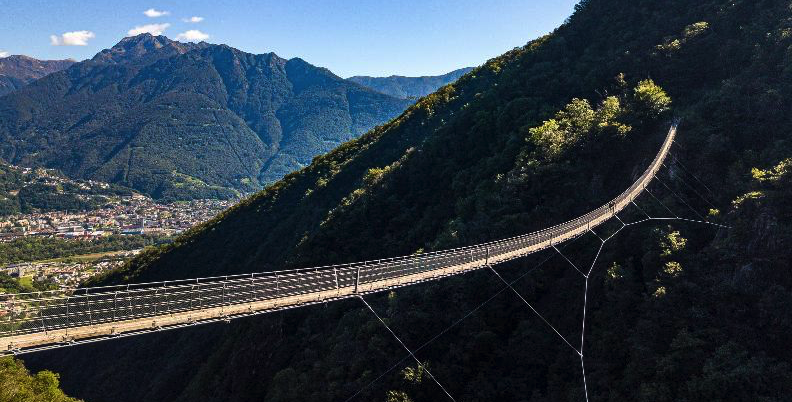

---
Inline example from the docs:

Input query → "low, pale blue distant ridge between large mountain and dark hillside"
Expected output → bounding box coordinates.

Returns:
[349,67,473,99]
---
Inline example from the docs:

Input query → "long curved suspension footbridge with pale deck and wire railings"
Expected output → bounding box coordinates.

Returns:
[0,122,677,356]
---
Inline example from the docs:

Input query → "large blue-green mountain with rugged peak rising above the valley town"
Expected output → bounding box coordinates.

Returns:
[0,34,409,198]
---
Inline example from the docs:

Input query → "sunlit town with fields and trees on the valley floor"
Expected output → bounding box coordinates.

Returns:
[0,165,238,292]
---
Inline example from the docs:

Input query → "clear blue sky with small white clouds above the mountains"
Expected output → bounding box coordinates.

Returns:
[0,0,577,77]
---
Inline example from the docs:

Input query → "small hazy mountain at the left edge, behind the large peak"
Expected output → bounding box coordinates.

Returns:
[0,55,75,96]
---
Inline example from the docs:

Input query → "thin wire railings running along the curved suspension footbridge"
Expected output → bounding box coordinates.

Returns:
[0,123,676,337]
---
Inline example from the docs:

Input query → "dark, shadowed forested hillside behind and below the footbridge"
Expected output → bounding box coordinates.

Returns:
[26,0,792,402]
